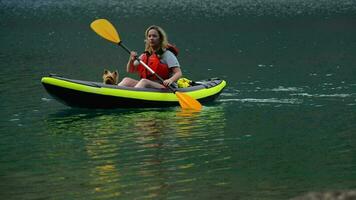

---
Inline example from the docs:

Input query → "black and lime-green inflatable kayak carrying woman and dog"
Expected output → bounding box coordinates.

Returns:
[41,75,226,108]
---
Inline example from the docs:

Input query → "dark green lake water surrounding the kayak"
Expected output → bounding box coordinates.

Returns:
[0,0,356,200]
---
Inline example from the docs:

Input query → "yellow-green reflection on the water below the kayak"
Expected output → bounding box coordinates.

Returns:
[46,107,231,199]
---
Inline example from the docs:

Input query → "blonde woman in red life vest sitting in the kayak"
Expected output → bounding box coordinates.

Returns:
[118,25,182,88]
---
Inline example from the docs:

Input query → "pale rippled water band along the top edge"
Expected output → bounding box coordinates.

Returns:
[1,0,356,18]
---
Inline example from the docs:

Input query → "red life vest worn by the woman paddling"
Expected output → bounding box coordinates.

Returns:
[137,44,178,80]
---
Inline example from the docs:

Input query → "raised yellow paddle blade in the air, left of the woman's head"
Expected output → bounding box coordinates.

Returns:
[90,19,121,44]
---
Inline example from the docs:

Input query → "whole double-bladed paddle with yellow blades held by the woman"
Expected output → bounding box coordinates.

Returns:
[90,19,202,111]
